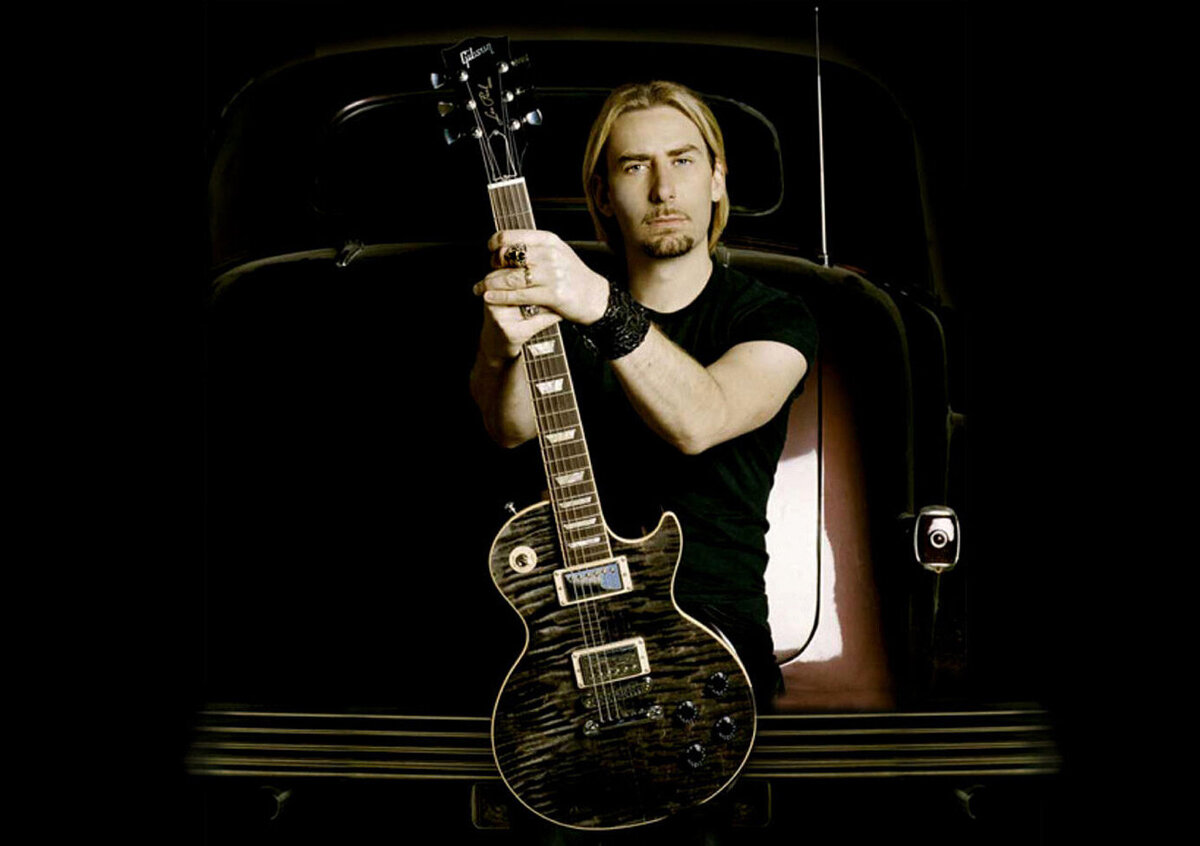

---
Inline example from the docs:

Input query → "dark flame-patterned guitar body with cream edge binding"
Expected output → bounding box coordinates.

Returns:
[491,503,755,829]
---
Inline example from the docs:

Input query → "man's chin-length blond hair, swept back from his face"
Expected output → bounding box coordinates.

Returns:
[583,80,730,252]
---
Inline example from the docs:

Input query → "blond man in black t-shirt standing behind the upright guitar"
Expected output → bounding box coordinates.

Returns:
[472,82,816,710]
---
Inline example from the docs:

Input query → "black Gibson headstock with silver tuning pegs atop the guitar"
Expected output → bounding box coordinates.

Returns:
[431,36,541,182]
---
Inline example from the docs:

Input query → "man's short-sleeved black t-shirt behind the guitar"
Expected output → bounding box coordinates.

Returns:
[564,263,817,626]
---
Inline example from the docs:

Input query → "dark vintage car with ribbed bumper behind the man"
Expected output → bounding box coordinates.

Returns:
[185,4,1080,844]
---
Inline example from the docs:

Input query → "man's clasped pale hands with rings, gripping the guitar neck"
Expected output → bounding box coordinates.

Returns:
[474,229,608,336]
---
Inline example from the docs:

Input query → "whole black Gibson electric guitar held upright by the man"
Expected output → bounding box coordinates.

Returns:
[433,38,756,829]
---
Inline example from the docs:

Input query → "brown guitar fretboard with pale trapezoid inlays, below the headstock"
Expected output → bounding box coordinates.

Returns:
[487,178,612,566]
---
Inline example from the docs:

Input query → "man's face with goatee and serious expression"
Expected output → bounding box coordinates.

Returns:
[596,106,725,258]
